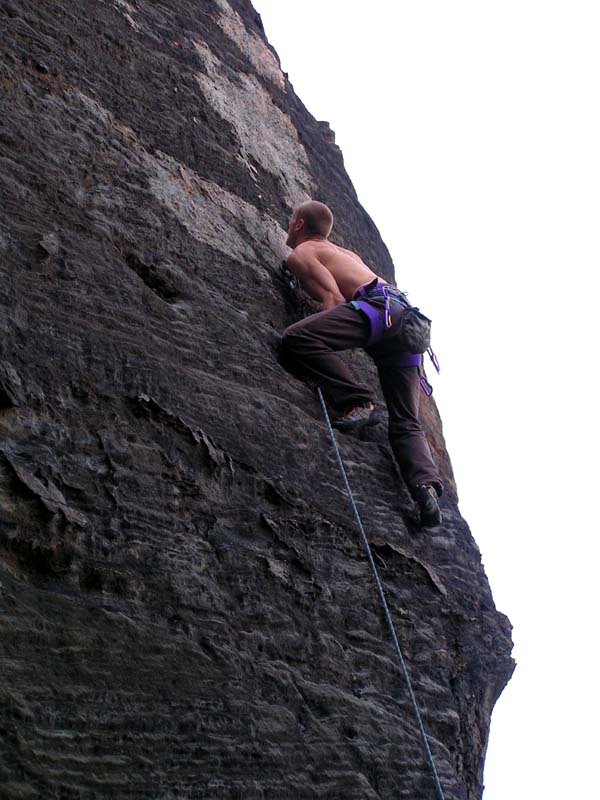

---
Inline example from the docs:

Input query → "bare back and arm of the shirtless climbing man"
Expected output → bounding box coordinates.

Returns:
[287,239,378,308]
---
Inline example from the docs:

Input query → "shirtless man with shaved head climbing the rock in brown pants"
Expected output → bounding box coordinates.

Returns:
[280,200,442,527]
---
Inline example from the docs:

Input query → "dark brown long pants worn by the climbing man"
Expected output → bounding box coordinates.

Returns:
[280,303,442,494]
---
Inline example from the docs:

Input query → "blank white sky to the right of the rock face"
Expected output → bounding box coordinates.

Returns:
[253,0,600,800]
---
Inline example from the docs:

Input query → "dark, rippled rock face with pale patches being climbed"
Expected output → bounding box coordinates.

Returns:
[0,0,512,800]
